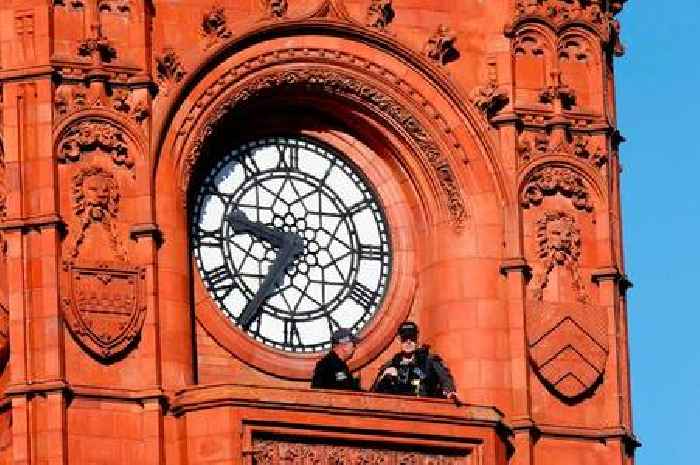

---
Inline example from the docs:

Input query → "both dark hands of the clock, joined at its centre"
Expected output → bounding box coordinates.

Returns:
[229,210,304,328]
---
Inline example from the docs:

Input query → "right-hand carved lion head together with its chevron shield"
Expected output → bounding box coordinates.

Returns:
[527,211,608,401]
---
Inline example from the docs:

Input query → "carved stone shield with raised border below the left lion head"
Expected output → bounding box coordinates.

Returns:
[63,263,146,360]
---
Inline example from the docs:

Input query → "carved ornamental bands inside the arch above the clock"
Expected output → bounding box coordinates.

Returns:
[178,49,467,227]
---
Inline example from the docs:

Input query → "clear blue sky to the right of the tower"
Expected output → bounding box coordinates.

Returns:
[616,0,700,465]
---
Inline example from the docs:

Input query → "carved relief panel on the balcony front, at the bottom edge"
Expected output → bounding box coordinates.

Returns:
[253,440,469,465]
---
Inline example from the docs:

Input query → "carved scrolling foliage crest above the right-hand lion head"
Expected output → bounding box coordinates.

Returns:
[520,166,593,211]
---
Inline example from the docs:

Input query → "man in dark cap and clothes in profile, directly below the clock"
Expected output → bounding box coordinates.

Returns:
[311,328,361,391]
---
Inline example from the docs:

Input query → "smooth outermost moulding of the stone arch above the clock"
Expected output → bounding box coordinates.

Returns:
[152,20,506,210]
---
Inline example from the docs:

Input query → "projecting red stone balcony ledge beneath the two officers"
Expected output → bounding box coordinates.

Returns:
[171,384,512,465]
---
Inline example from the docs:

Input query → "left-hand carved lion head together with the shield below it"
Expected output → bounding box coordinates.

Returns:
[62,166,146,361]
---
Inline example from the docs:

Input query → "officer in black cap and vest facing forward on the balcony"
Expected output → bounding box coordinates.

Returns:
[372,321,459,403]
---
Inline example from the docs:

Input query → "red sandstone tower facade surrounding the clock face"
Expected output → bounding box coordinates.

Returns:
[0,0,636,465]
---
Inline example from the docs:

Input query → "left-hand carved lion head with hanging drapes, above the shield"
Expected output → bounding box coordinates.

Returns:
[66,166,127,263]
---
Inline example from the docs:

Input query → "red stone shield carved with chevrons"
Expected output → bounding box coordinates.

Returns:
[527,300,608,399]
